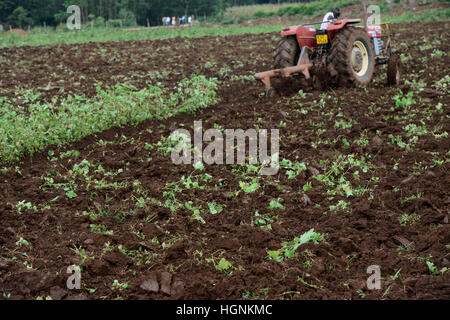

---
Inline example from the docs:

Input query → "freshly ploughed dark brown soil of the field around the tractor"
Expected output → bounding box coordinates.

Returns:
[0,23,450,299]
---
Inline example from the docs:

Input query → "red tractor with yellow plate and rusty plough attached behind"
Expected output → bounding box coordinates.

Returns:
[255,7,401,94]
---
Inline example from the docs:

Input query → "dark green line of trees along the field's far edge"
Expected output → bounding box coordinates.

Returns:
[0,0,311,28]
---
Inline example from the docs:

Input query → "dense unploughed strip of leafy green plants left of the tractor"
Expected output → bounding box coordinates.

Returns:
[0,76,218,163]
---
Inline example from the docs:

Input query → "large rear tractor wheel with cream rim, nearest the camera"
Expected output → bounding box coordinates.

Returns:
[329,27,375,86]
